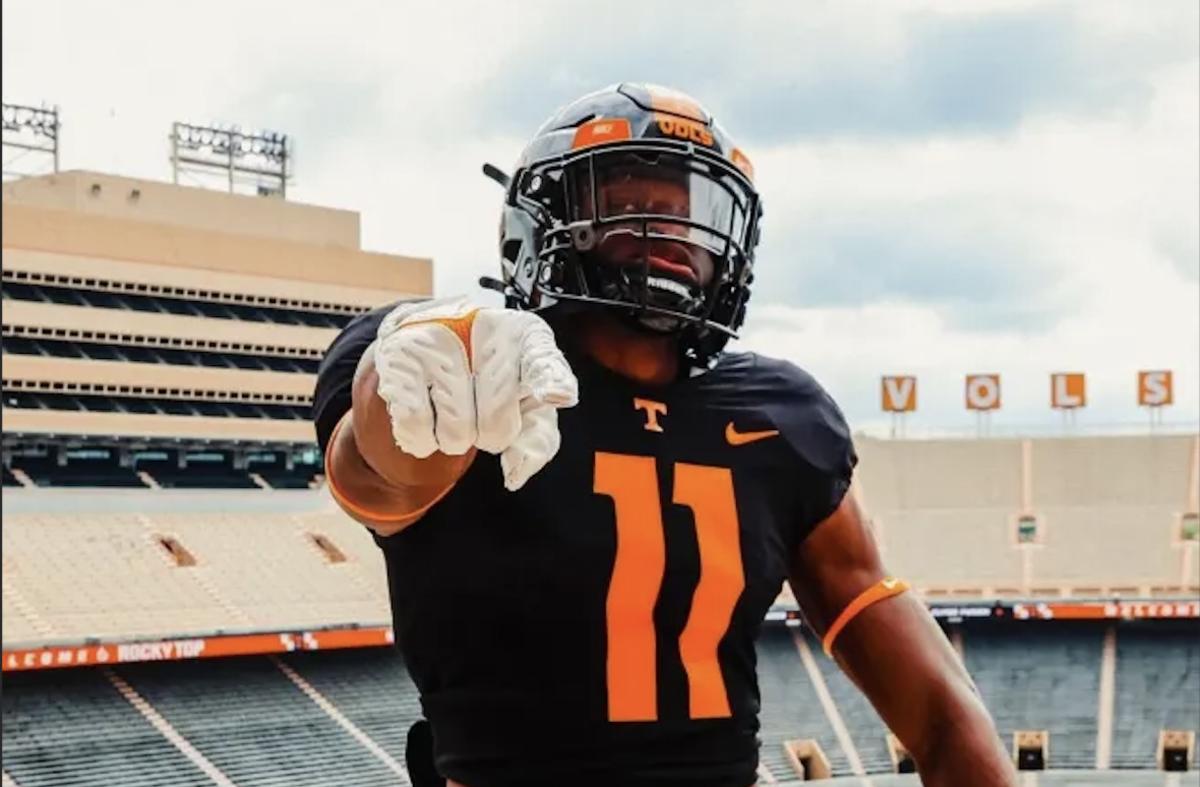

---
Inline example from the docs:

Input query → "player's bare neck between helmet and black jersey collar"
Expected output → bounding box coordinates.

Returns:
[578,313,679,385]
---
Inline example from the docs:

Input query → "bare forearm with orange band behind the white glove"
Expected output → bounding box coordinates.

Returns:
[328,357,475,535]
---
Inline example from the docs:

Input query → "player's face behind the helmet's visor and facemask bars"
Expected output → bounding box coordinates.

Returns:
[581,162,715,287]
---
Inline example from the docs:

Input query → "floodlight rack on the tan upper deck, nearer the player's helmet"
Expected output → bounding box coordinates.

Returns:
[170,121,293,198]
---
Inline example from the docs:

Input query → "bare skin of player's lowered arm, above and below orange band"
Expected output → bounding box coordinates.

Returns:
[791,494,1016,787]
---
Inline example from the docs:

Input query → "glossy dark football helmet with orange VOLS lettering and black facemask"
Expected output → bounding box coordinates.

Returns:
[485,83,762,366]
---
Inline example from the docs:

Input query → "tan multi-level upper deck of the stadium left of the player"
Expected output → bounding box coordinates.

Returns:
[0,172,432,483]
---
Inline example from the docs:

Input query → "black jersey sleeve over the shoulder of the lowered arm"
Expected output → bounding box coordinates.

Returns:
[758,356,858,543]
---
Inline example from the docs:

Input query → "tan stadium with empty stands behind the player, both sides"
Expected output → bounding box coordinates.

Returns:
[2,152,1200,787]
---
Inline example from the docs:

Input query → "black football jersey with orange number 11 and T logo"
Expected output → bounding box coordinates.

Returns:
[314,310,856,787]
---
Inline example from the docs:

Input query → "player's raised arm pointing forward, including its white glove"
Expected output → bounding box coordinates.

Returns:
[318,299,578,536]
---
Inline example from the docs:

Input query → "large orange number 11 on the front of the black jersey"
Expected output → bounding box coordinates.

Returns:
[594,452,745,721]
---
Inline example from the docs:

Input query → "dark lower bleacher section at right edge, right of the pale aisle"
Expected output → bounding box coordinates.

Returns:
[1111,621,1200,768]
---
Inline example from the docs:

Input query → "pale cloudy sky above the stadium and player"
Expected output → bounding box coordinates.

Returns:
[2,0,1200,433]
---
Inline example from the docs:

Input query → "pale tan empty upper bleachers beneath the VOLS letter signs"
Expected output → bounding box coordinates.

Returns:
[856,434,1200,596]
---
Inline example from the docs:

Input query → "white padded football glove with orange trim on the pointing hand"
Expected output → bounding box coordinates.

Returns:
[373,298,578,491]
